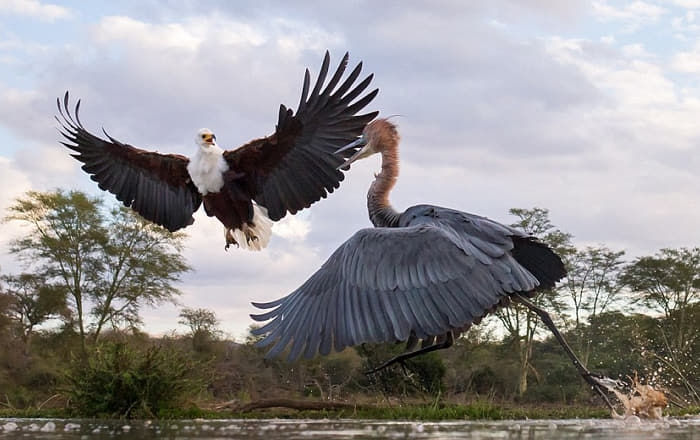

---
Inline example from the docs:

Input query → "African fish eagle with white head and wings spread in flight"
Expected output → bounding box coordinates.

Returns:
[56,52,379,250]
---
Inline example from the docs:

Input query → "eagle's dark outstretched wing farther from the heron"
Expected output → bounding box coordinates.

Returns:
[56,92,201,231]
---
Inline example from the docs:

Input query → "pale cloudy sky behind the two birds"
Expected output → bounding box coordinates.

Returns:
[0,0,700,338]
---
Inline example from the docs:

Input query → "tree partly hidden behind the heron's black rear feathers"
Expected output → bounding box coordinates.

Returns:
[496,208,574,396]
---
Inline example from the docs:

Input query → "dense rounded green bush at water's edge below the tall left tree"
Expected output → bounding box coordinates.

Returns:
[67,342,206,418]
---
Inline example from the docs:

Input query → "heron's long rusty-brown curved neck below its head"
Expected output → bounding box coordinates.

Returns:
[367,146,400,227]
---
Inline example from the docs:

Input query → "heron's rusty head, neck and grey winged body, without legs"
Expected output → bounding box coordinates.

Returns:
[253,120,566,359]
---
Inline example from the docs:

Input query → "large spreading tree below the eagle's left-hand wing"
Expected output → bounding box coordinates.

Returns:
[6,190,189,352]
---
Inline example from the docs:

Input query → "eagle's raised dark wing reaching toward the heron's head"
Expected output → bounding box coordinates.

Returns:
[224,52,378,221]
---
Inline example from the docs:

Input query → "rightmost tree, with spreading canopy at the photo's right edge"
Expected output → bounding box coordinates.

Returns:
[622,248,700,349]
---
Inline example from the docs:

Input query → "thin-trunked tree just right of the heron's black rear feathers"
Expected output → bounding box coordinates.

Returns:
[560,246,625,365]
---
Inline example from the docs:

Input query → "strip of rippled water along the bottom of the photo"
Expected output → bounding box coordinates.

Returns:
[0,416,700,440]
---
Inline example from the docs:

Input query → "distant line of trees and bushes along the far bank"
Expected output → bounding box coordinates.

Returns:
[0,191,700,417]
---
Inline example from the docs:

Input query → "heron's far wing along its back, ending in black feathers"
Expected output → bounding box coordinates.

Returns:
[400,205,566,289]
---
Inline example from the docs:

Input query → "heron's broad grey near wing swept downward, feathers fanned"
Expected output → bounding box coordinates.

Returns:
[252,224,537,360]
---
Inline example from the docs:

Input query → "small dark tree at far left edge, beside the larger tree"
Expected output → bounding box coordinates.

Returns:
[0,273,68,350]
